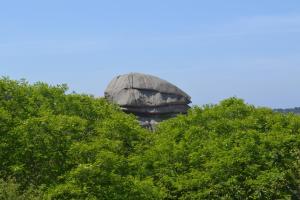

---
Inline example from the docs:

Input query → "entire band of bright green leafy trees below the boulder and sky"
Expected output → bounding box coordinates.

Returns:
[0,78,300,200]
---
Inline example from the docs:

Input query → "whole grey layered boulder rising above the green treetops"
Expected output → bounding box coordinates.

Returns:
[105,73,191,129]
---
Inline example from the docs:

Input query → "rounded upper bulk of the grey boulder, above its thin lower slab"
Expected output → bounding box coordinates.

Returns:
[105,73,191,107]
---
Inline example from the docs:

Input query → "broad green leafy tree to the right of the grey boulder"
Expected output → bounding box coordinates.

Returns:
[139,98,300,199]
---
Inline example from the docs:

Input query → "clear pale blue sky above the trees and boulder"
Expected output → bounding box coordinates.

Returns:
[0,0,300,108]
